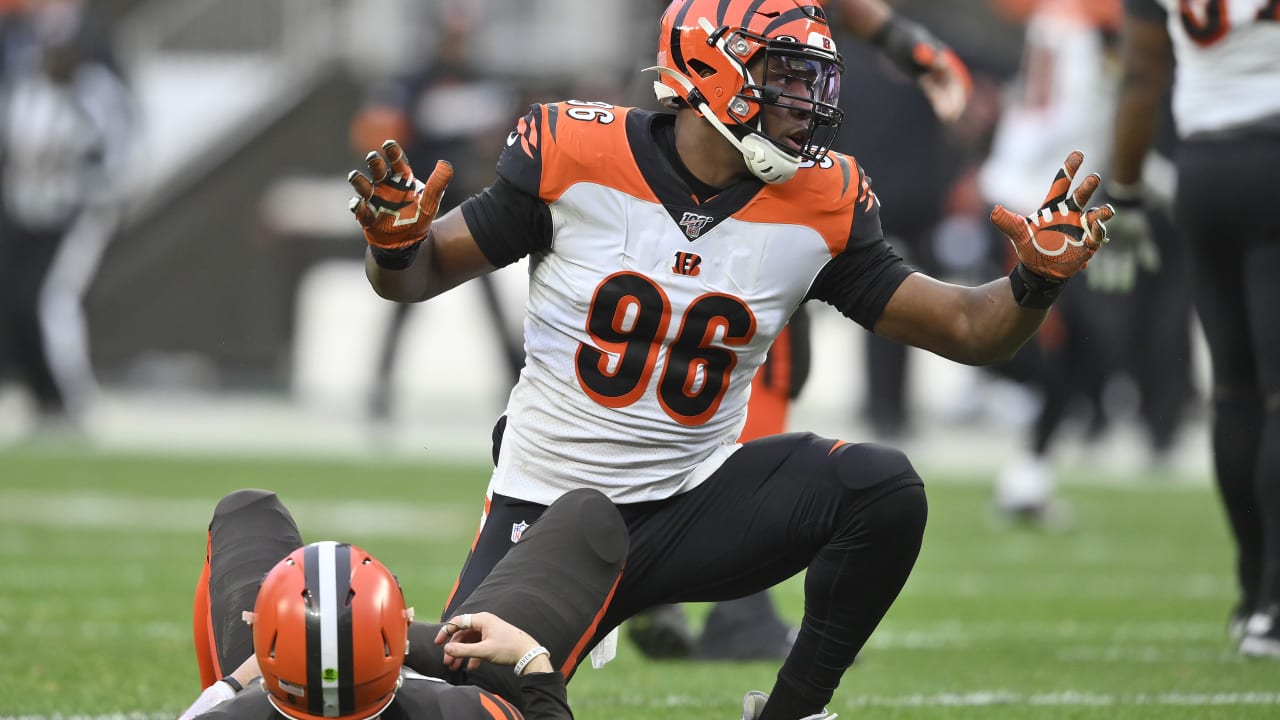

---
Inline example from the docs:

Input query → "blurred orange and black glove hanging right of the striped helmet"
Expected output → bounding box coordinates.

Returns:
[870,14,973,123]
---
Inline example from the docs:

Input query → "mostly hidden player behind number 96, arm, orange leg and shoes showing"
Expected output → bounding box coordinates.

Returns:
[627,0,972,660]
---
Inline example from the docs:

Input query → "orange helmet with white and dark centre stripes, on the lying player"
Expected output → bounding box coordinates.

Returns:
[252,542,413,720]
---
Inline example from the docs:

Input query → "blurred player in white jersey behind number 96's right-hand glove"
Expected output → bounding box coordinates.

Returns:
[978,0,1120,527]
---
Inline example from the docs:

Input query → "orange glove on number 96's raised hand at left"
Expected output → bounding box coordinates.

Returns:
[347,140,453,270]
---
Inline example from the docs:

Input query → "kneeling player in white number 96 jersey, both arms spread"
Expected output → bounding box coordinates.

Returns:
[348,0,1111,720]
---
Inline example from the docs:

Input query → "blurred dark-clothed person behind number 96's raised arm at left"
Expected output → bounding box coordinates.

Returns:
[351,1,524,420]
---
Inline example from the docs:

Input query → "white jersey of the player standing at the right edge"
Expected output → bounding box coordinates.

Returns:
[1160,0,1280,137]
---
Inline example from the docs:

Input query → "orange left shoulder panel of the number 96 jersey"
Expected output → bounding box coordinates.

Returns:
[539,102,658,202]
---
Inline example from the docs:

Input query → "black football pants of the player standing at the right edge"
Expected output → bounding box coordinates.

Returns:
[1176,131,1280,611]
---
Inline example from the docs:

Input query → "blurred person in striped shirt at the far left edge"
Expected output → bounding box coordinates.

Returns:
[0,0,134,432]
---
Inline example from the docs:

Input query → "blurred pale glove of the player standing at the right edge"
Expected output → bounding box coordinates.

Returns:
[1084,182,1160,293]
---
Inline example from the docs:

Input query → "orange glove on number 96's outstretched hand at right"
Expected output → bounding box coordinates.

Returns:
[991,151,1115,307]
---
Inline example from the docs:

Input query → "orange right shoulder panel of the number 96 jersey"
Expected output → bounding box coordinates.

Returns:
[733,152,870,256]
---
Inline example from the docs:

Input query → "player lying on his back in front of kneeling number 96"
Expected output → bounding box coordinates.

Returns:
[182,488,627,720]
